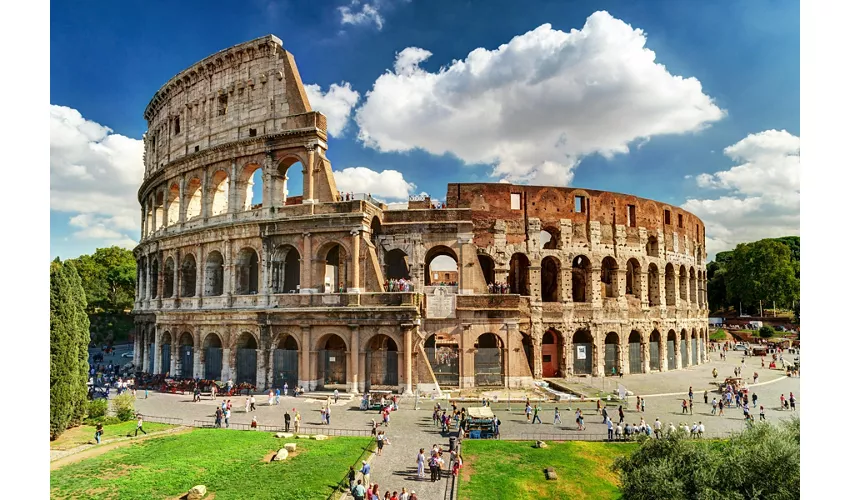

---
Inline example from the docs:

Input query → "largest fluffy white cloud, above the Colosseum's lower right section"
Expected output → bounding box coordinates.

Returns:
[355,12,725,185]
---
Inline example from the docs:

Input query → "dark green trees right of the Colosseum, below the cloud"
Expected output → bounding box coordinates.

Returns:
[706,236,800,320]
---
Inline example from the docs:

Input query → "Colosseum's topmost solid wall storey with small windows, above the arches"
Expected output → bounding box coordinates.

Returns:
[144,35,327,178]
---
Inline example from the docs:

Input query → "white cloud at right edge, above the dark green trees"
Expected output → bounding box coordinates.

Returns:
[682,130,800,258]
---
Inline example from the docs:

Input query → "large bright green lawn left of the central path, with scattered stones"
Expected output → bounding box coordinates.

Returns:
[50,429,371,500]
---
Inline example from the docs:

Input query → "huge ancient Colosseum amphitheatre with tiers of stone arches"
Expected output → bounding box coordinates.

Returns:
[129,36,708,393]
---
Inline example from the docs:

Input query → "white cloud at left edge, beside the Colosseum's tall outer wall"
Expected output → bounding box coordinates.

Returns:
[50,105,144,252]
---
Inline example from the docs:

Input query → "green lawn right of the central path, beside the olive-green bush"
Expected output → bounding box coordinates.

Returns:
[458,439,637,500]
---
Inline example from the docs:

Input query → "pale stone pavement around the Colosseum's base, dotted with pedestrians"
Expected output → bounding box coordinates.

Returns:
[121,353,804,500]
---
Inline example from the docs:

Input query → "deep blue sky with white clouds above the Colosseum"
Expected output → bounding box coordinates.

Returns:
[50,0,800,258]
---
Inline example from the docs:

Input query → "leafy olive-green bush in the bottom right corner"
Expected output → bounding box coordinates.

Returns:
[613,418,800,500]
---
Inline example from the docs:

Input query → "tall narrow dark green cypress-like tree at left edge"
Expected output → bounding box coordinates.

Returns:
[50,259,89,439]
